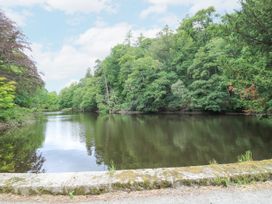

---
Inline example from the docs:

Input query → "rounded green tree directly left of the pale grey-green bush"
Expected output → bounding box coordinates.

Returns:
[124,57,173,112]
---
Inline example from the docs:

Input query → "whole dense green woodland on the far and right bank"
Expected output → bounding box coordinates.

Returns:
[60,0,272,113]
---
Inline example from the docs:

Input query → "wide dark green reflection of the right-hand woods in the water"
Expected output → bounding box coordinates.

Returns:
[95,115,272,169]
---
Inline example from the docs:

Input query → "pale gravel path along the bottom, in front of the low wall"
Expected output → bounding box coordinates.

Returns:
[0,181,272,204]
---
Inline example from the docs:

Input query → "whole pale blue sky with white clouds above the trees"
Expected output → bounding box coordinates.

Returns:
[0,0,239,92]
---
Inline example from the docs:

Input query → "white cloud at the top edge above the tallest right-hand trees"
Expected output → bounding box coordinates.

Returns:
[140,0,239,18]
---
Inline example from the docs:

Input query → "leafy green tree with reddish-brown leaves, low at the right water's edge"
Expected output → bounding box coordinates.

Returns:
[223,46,272,113]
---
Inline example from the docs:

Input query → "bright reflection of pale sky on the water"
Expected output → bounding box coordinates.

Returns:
[39,115,107,172]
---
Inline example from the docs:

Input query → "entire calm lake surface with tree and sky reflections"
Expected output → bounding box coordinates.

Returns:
[0,113,272,172]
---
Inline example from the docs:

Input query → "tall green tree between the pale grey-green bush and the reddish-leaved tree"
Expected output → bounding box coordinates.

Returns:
[188,39,228,112]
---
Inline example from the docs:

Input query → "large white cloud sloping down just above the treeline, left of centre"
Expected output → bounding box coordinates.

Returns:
[32,23,159,88]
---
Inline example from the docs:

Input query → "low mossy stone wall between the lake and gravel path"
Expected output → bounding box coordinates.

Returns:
[0,160,272,196]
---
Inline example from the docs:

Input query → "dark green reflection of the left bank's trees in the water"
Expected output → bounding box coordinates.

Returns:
[0,123,45,173]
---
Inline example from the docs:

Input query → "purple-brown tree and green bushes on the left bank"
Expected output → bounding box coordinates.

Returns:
[0,11,58,122]
